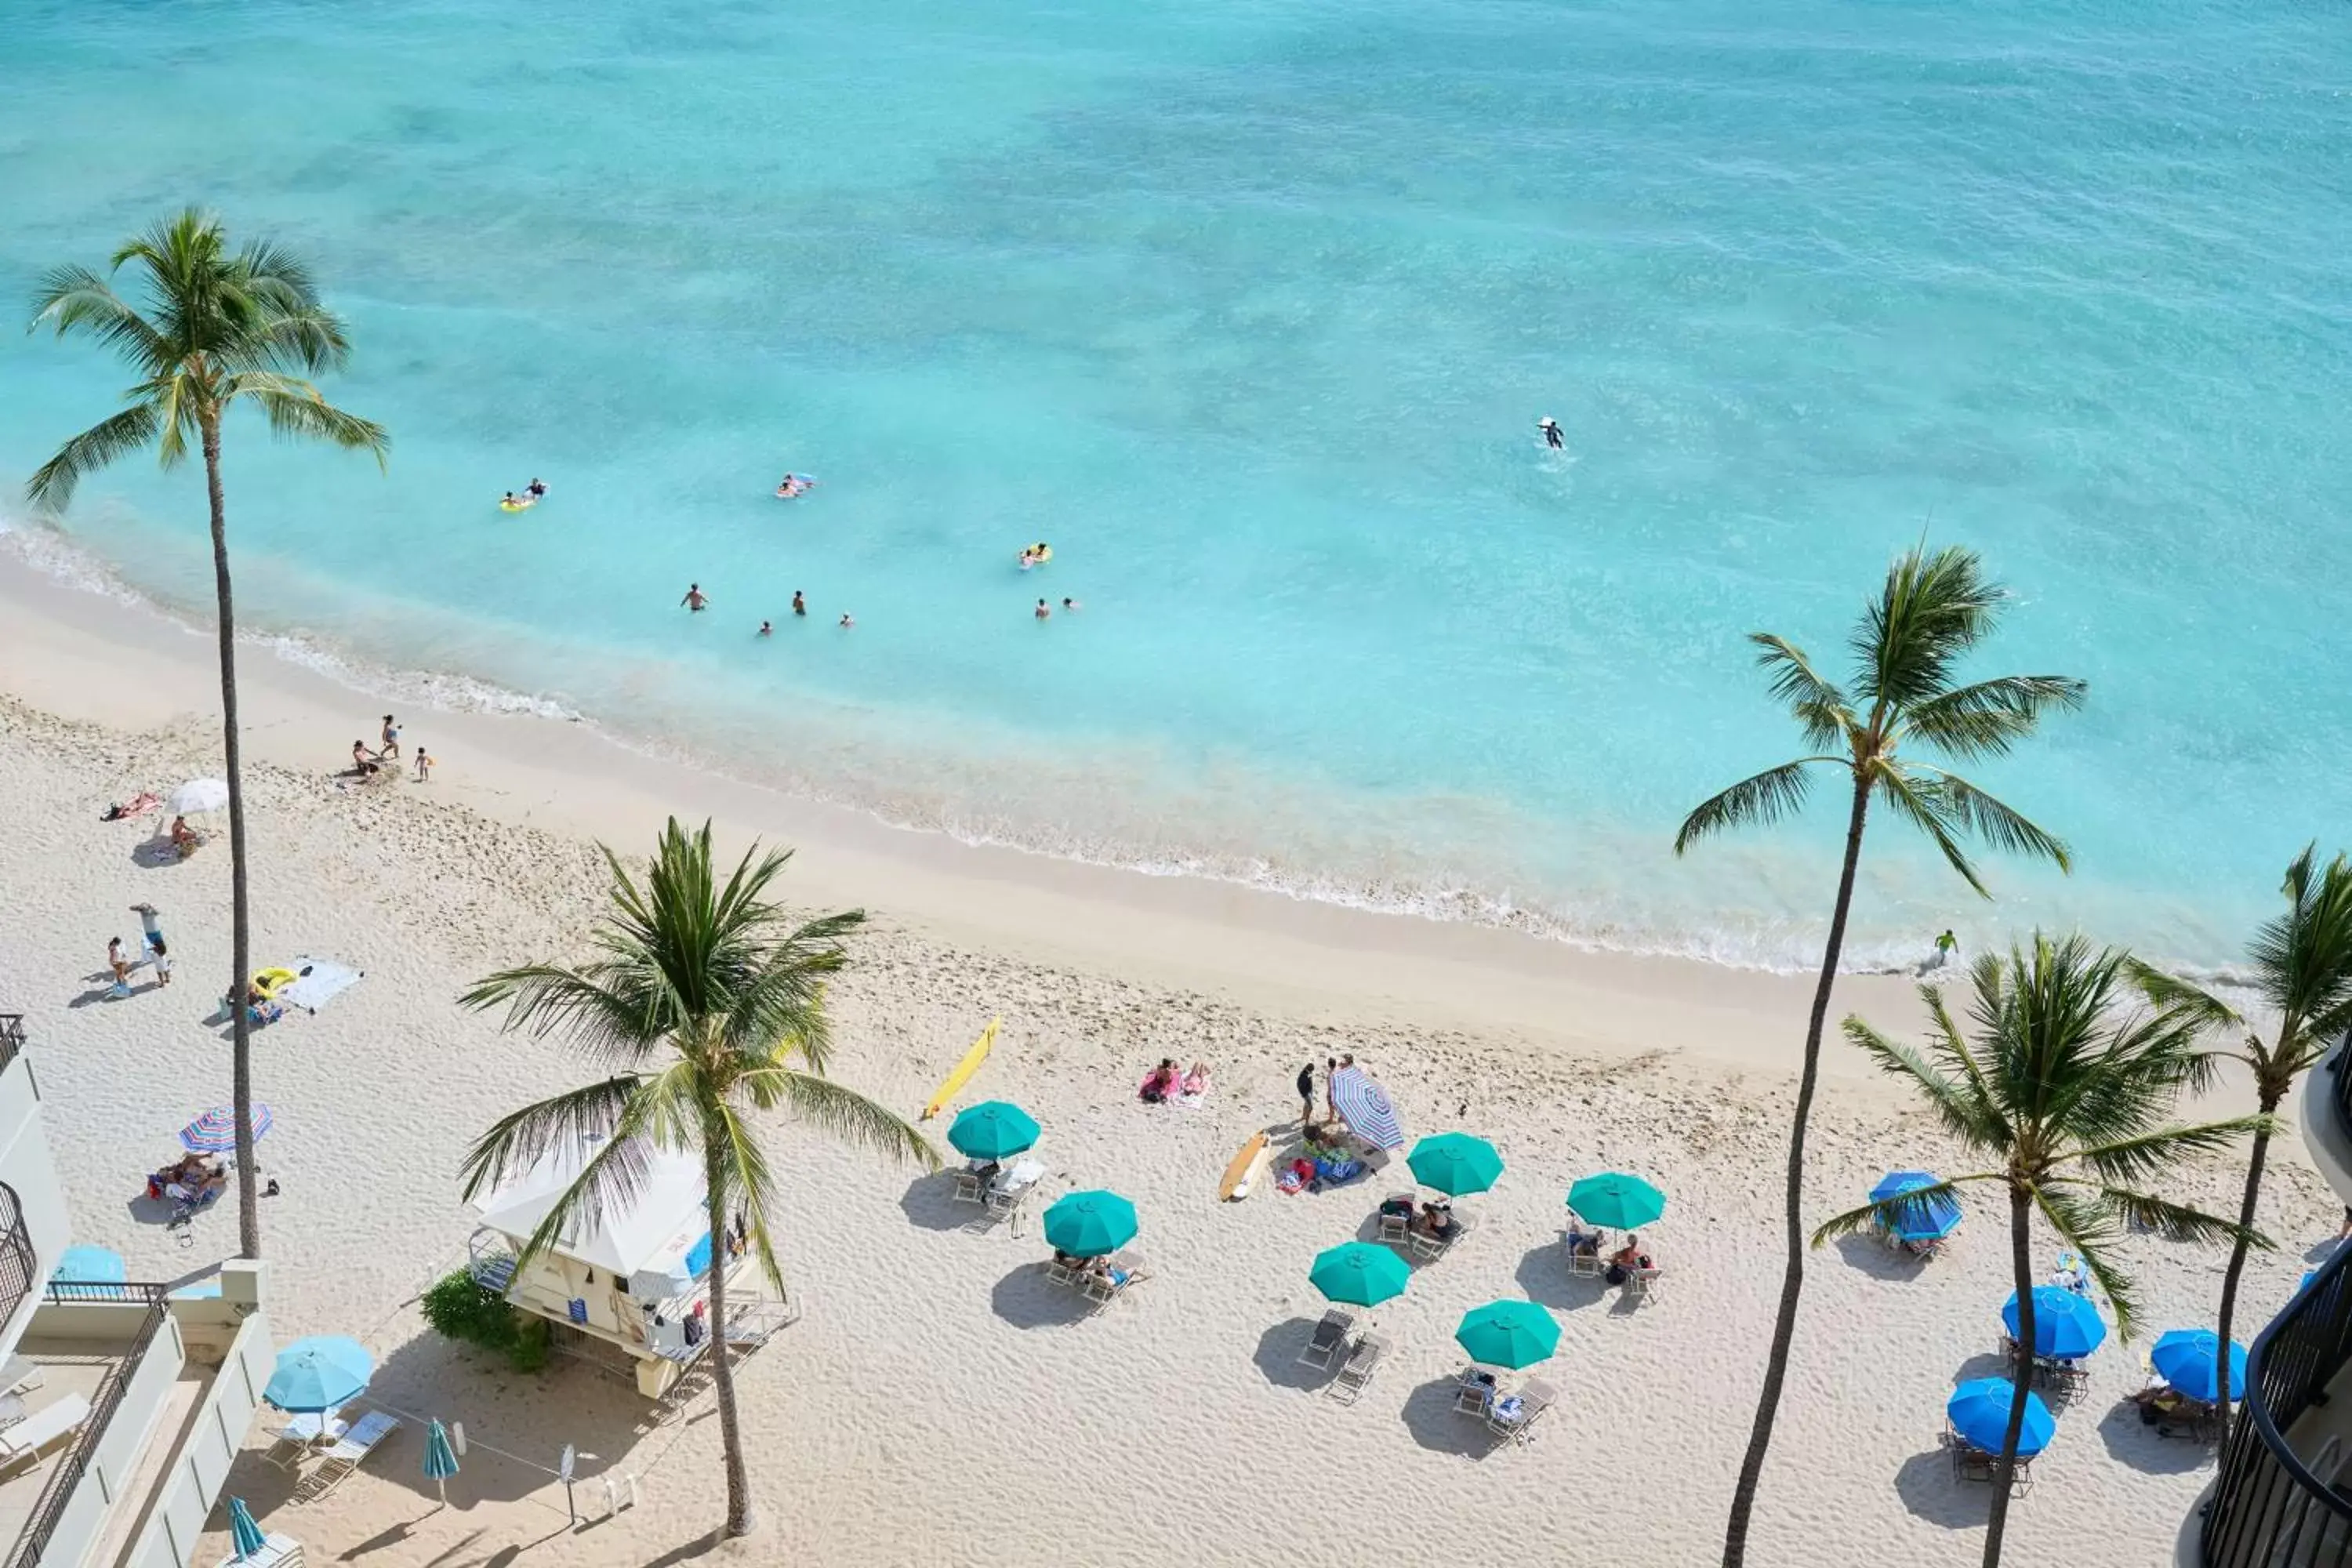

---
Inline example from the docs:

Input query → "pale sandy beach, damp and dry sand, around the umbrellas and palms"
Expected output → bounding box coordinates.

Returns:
[0,557,2336,1568]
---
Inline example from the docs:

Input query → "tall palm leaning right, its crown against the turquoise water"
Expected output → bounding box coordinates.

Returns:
[1675,546,2084,1568]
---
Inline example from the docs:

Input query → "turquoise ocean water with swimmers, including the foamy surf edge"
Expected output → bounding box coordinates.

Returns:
[0,0,2352,964]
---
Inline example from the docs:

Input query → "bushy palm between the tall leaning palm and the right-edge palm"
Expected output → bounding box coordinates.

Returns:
[1813,931,2267,1568]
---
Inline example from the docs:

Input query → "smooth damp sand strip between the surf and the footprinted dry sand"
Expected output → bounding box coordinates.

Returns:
[0,540,1915,1076]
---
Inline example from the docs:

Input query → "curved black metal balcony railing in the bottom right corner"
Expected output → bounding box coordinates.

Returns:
[2197,1248,2352,1568]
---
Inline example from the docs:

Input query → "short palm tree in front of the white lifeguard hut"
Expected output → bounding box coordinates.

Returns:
[461,818,938,1535]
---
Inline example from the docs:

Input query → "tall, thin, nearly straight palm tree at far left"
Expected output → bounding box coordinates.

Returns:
[26,207,390,1258]
